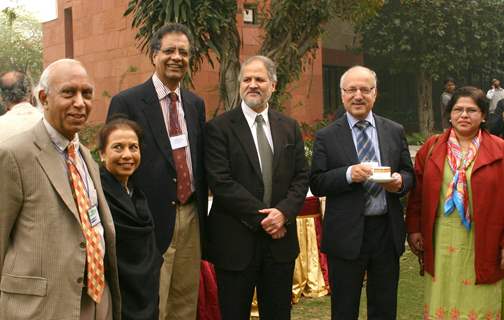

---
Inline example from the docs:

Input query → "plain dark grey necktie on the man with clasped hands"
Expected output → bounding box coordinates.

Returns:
[256,114,273,207]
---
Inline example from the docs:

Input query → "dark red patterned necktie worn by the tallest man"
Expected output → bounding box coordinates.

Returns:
[168,92,192,204]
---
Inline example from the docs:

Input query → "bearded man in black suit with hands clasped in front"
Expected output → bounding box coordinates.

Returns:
[205,56,308,320]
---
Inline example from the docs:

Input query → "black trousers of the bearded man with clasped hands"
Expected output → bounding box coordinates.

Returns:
[215,234,294,320]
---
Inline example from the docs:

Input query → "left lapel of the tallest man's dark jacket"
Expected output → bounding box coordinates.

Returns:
[141,79,175,169]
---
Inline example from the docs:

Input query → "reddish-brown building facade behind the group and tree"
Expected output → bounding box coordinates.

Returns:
[43,0,362,124]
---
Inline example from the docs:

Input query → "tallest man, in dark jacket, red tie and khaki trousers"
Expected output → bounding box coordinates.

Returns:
[108,23,208,320]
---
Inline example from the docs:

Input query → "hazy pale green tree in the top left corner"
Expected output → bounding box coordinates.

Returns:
[0,8,42,79]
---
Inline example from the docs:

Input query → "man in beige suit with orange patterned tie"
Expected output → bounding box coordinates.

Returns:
[0,59,120,320]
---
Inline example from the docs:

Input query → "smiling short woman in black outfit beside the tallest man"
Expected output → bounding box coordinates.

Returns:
[98,118,162,320]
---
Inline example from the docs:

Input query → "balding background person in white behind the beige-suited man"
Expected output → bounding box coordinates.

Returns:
[0,71,42,142]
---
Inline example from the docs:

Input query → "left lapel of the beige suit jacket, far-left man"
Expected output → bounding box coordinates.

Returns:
[34,122,80,221]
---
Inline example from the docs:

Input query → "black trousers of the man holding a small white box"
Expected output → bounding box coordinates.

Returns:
[328,215,399,320]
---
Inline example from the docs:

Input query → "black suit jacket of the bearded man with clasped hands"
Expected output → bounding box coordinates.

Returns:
[205,106,308,270]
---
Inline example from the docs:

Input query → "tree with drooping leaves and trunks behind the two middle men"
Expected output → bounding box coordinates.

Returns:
[124,0,383,110]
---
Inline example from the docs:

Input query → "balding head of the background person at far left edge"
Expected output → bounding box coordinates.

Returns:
[0,71,32,105]
